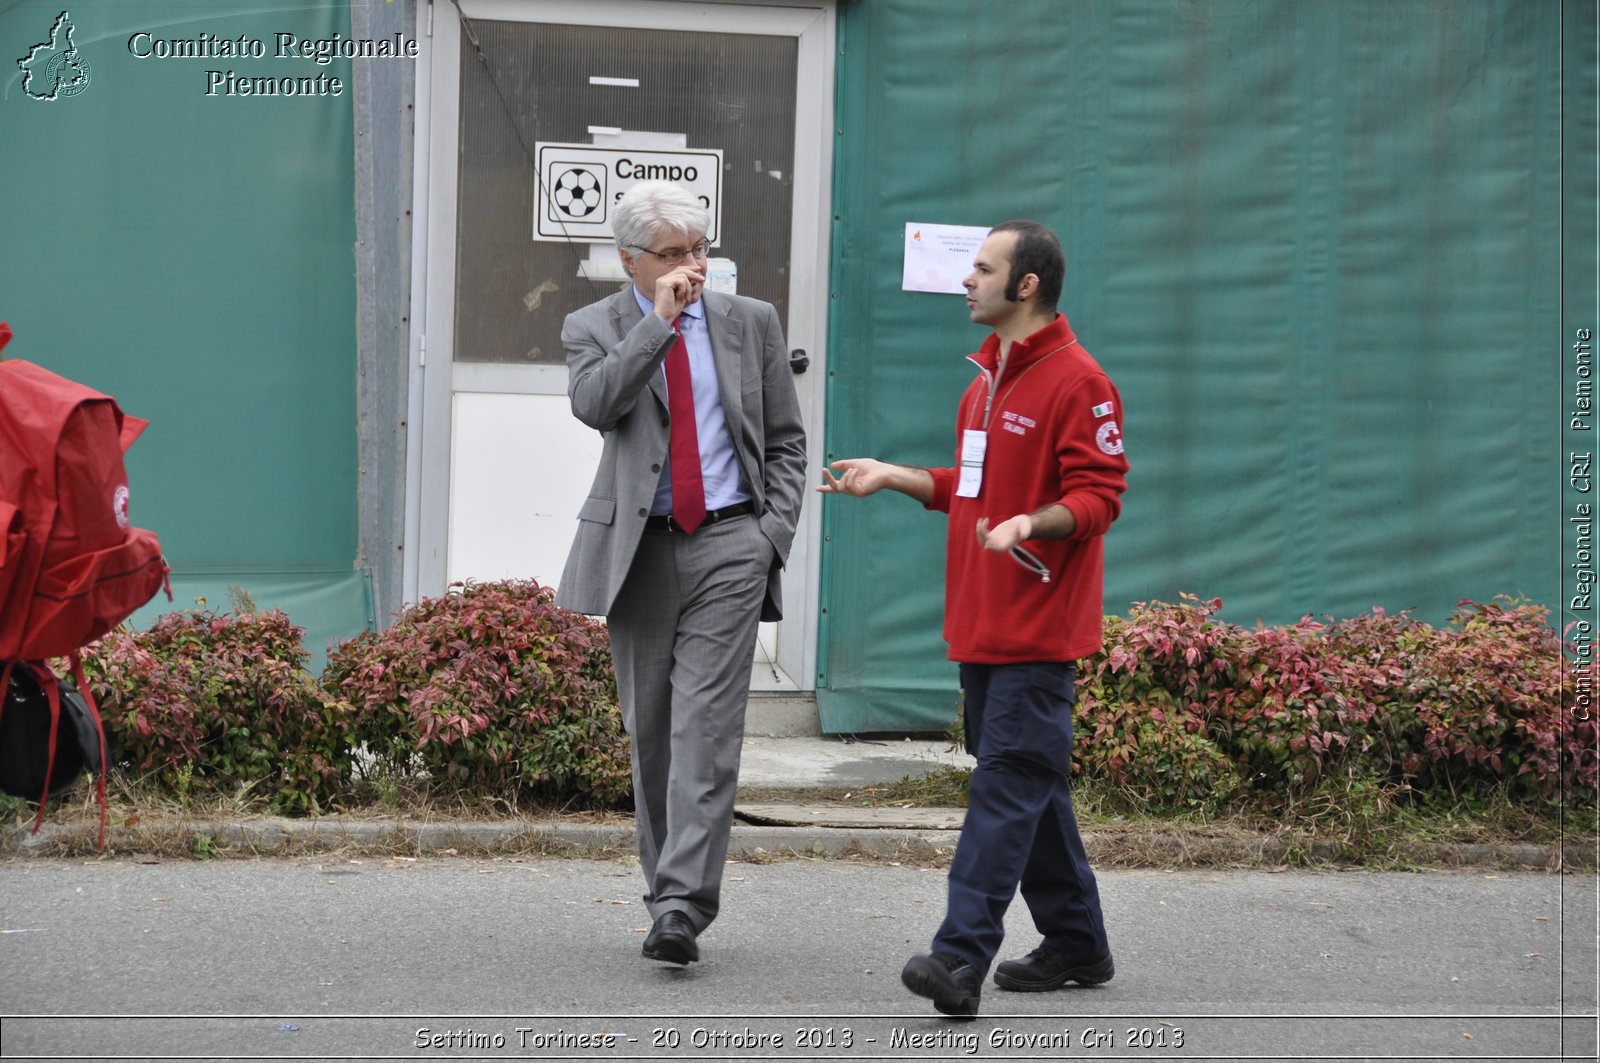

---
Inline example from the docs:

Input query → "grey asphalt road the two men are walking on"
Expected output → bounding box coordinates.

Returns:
[0,856,1597,1060]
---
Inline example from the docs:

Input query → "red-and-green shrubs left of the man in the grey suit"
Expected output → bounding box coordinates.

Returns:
[83,581,632,813]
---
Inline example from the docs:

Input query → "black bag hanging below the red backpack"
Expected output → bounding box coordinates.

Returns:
[0,664,101,800]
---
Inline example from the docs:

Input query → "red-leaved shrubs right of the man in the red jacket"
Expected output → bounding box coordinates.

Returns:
[1074,594,1600,807]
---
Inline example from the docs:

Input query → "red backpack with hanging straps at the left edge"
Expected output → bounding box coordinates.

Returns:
[0,322,171,844]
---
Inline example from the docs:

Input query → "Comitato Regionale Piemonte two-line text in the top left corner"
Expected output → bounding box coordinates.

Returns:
[128,30,418,96]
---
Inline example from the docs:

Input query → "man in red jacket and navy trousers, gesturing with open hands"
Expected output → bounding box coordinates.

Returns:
[818,221,1128,1017]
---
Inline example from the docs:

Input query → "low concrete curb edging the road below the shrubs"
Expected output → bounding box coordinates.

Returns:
[0,816,1562,871]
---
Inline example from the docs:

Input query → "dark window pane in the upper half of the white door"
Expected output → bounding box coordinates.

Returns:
[454,19,798,365]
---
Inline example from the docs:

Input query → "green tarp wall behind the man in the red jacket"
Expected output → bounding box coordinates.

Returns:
[818,0,1595,732]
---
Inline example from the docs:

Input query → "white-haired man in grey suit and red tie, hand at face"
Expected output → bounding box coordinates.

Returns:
[555,181,805,964]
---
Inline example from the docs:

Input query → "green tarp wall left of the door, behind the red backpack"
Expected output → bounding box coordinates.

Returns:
[0,0,370,656]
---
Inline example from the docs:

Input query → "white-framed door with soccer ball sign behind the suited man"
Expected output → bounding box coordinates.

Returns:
[405,0,834,690]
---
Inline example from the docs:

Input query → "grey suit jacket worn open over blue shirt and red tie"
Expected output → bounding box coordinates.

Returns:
[555,285,806,620]
